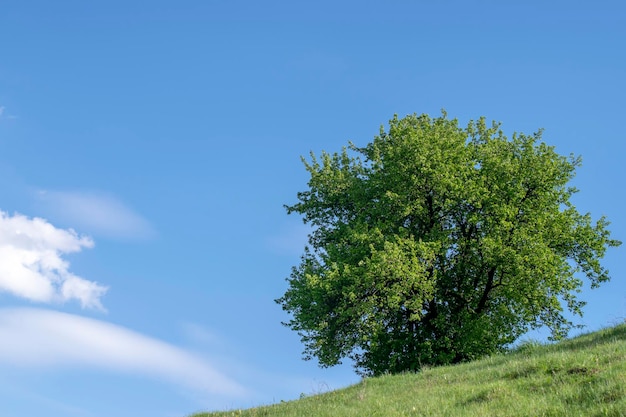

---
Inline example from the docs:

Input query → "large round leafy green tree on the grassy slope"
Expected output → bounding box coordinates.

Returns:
[276,112,621,375]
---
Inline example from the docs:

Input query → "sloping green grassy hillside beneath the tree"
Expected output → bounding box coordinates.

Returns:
[193,324,626,417]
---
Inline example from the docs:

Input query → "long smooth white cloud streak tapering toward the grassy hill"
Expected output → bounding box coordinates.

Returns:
[0,308,248,398]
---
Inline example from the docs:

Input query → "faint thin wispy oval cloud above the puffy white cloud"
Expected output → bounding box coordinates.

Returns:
[38,191,154,239]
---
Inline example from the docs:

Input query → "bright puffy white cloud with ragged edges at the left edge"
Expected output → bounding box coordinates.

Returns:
[0,211,107,310]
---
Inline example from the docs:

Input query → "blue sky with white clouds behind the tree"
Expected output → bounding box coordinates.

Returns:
[0,0,626,417]
